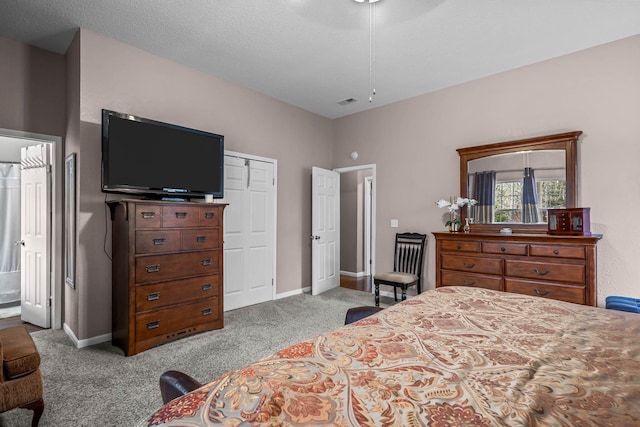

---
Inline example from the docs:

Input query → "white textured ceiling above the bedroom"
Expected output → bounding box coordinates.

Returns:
[0,0,640,118]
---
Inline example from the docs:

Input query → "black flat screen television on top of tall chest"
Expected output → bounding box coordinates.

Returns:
[102,110,224,200]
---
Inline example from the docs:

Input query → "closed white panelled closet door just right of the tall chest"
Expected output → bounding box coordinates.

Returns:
[222,155,275,310]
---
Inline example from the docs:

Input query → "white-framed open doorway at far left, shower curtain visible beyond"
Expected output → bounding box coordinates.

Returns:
[0,129,62,328]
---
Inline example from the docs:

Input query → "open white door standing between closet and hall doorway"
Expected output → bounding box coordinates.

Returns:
[311,167,340,295]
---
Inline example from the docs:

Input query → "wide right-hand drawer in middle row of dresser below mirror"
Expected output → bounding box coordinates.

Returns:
[505,260,585,283]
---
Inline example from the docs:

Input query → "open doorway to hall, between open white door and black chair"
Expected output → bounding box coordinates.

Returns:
[335,165,375,292]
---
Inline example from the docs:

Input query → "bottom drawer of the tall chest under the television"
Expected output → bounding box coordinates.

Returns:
[136,298,220,341]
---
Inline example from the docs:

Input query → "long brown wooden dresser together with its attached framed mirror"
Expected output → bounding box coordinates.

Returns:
[433,131,602,306]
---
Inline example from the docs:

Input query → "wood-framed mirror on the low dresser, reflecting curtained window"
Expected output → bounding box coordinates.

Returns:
[457,131,582,233]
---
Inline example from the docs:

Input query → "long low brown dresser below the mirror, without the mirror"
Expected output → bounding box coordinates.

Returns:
[433,233,602,306]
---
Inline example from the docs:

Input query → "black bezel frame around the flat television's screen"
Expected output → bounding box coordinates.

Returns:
[100,109,224,200]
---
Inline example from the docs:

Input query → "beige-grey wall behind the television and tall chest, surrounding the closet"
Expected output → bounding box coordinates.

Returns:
[67,30,333,339]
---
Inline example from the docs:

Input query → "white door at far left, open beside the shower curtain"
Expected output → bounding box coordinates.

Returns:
[20,144,51,328]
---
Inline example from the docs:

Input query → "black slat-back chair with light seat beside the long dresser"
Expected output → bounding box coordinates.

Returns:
[373,233,427,307]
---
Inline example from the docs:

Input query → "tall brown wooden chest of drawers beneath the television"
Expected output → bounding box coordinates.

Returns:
[107,200,226,356]
